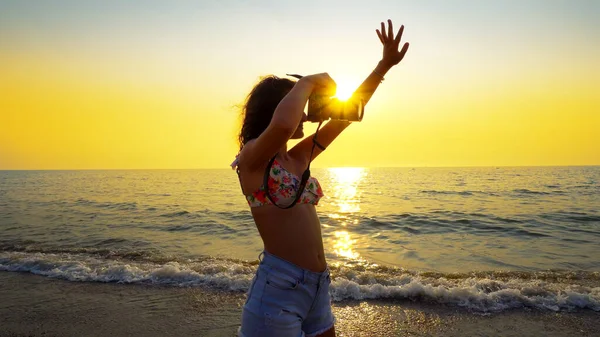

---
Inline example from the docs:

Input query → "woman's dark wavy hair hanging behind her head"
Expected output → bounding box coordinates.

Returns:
[238,75,296,150]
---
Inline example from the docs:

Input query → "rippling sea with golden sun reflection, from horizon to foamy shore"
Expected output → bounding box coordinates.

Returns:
[0,167,600,312]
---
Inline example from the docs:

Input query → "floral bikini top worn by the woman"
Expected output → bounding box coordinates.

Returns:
[231,154,323,207]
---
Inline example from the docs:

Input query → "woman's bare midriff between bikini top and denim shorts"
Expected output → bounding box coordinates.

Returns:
[252,204,327,272]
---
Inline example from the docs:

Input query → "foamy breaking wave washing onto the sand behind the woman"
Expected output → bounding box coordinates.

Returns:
[0,251,600,312]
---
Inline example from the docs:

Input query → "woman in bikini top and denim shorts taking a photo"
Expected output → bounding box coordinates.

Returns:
[232,20,408,337]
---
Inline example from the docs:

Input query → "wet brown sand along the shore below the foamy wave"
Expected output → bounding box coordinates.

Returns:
[0,272,600,337]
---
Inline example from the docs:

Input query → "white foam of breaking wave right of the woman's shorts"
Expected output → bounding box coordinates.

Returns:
[330,272,600,312]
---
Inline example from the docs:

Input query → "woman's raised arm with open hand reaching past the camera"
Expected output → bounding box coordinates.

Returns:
[292,20,409,161]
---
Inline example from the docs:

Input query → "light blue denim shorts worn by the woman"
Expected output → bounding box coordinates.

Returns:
[238,251,335,337]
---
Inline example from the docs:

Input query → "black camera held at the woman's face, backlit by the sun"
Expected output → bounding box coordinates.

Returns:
[307,93,365,122]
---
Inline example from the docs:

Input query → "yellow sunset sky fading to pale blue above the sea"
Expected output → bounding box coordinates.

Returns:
[0,0,600,169]
